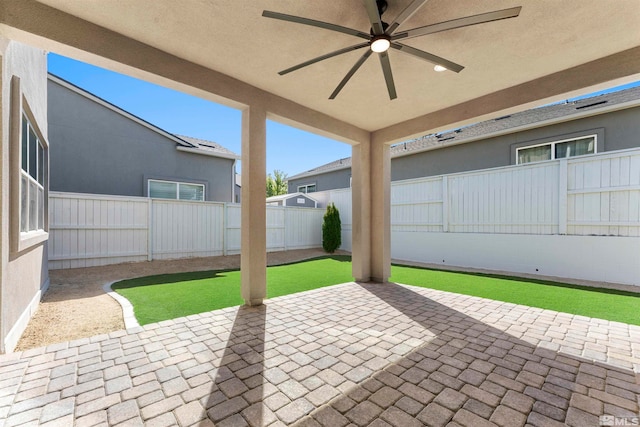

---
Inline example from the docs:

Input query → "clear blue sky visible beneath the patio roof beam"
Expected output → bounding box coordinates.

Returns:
[48,53,351,176]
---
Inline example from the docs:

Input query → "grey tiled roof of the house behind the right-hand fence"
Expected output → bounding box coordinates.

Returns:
[288,86,640,180]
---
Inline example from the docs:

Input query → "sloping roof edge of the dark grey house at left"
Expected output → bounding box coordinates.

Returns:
[47,73,240,159]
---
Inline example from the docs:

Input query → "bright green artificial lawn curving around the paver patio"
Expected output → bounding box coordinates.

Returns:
[113,256,640,325]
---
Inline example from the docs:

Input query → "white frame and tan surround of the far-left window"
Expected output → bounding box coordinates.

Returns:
[9,76,49,252]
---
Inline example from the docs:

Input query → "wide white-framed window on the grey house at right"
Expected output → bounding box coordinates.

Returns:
[516,135,597,164]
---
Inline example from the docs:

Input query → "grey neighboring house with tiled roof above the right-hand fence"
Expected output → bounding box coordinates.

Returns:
[288,87,640,193]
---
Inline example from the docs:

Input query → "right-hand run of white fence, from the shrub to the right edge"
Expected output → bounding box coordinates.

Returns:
[314,149,640,285]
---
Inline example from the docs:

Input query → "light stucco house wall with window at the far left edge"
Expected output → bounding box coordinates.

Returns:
[0,41,49,354]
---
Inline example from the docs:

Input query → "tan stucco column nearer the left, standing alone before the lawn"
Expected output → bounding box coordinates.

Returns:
[240,106,267,305]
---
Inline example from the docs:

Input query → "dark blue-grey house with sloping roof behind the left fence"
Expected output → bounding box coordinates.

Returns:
[48,74,239,202]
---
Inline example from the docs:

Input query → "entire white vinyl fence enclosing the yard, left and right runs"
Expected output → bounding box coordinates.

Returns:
[49,149,640,285]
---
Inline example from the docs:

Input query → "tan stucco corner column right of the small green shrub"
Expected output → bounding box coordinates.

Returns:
[351,139,391,282]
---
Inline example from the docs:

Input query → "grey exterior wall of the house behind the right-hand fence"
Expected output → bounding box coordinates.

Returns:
[298,107,640,193]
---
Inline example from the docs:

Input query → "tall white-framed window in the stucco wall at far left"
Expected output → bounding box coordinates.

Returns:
[20,114,47,233]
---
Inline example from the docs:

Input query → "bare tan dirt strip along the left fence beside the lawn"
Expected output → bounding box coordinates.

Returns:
[16,249,342,351]
